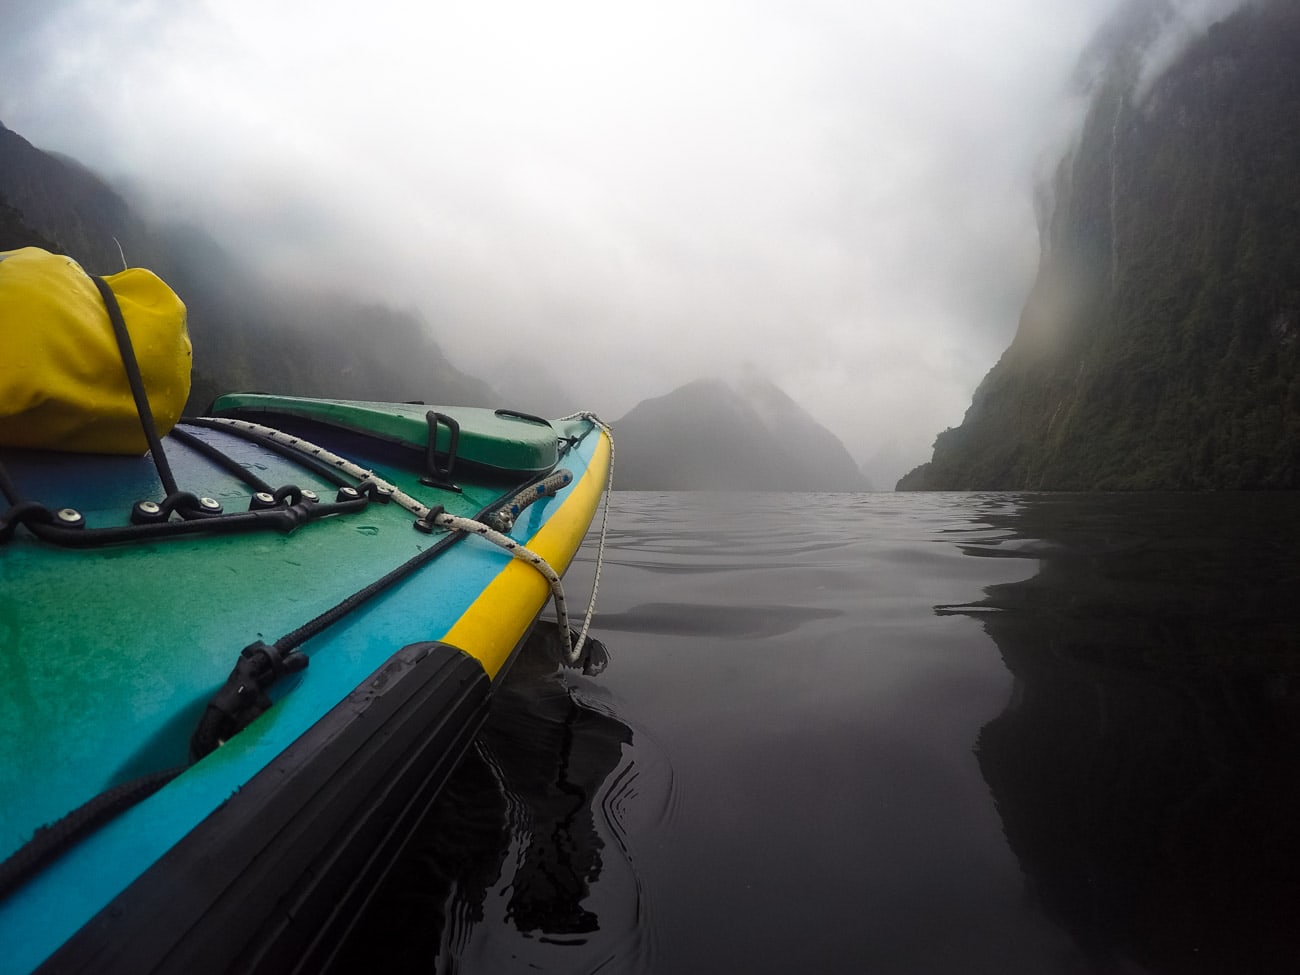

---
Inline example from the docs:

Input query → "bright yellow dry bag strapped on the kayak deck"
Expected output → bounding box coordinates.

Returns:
[0,247,192,454]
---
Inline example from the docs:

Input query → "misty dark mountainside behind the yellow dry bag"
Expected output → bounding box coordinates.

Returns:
[0,125,493,413]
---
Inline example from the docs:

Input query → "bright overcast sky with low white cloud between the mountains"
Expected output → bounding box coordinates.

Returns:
[0,0,1232,488]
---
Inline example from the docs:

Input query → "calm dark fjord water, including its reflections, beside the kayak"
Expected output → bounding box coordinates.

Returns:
[347,493,1300,974]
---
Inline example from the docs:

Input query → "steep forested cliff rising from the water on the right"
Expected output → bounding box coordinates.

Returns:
[898,0,1300,490]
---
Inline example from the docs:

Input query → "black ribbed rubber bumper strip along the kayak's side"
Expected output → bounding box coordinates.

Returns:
[40,642,491,975]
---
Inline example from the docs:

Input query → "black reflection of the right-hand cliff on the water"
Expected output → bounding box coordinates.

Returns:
[940,495,1300,972]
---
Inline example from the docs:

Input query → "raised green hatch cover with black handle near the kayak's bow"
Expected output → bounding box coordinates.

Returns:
[212,393,558,473]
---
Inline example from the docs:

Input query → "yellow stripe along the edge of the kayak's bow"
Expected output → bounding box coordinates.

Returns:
[442,430,610,680]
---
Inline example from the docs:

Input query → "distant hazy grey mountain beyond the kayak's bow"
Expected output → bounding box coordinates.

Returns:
[614,376,868,491]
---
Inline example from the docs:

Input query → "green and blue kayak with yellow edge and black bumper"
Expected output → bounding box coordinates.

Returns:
[0,394,612,972]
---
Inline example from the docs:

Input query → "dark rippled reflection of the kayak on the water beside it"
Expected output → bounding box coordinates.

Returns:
[339,624,655,972]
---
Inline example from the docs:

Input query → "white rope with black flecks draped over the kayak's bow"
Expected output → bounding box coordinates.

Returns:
[202,413,614,666]
